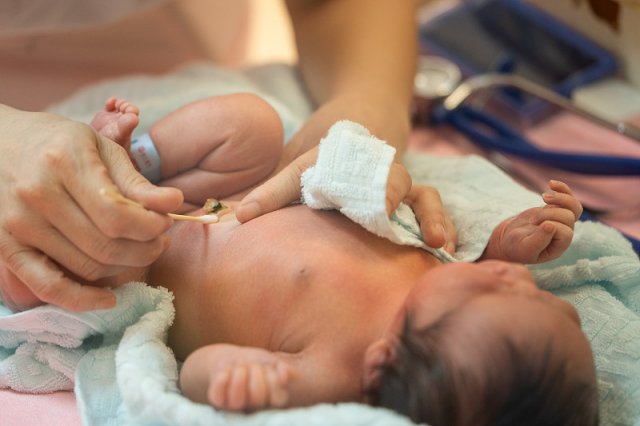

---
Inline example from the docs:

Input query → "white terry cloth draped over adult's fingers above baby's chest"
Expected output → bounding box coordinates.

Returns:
[301,120,453,261]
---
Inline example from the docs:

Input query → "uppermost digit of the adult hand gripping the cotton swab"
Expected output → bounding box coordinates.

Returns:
[98,135,184,213]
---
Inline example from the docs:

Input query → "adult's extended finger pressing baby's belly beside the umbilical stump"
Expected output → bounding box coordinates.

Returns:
[236,148,318,223]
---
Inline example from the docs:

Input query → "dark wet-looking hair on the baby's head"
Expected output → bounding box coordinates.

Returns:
[369,315,599,426]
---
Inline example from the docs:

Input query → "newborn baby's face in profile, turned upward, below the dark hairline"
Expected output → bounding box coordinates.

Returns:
[405,261,594,380]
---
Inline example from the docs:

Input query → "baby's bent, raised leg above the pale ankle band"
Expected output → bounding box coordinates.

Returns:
[149,93,283,206]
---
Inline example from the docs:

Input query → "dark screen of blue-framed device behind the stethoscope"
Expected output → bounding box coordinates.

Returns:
[420,1,597,88]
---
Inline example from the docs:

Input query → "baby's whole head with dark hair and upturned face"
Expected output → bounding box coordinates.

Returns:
[365,261,598,426]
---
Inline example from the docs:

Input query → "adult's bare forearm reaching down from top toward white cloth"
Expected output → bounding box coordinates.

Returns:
[287,0,416,153]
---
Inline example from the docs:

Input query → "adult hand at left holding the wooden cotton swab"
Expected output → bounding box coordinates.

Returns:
[0,105,182,310]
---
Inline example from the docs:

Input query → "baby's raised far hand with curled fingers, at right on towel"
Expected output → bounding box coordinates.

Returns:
[482,180,582,264]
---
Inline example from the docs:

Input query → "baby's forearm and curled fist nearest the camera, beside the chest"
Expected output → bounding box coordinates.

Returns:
[180,344,359,412]
